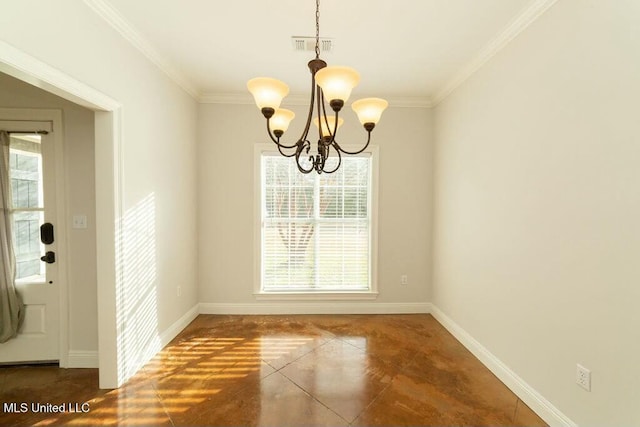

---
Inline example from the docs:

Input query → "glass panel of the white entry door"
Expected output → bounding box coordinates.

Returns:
[9,135,45,283]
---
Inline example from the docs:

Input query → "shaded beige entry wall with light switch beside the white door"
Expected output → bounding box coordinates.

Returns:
[0,73,98,351]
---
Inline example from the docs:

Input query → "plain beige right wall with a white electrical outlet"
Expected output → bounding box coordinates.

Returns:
[433,0,640,425]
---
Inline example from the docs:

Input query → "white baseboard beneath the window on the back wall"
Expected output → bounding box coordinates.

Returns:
[200,301,431,315]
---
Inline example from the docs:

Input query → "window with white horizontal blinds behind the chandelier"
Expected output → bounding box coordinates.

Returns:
[260,148,375,294]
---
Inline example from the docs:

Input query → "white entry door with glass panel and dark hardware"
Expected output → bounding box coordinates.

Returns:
[0,121,60,363]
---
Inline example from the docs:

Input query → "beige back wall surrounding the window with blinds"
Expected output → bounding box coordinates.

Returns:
[198,104,432,311]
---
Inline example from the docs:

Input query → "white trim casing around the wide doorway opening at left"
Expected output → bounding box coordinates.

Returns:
[0,40,123,388]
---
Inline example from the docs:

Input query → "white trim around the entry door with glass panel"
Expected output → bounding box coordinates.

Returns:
[0,108,69,368]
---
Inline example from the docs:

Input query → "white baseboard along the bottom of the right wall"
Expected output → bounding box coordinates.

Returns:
[431,305,577,427]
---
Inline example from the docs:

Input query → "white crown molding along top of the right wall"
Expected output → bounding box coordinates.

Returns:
[433,0,558,106]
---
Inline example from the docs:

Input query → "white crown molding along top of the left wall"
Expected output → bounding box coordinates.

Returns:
[84,0,199,100]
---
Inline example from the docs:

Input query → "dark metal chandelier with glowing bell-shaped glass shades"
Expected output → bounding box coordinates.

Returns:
[247,0,389,174]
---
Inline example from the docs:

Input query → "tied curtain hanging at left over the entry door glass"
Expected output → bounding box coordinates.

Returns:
[0,131,24,343]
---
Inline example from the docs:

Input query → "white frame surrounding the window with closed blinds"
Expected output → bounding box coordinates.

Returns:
[253,144,379,301]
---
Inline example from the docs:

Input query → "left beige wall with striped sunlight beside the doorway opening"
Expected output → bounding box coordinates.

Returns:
[0,0,198,385]
